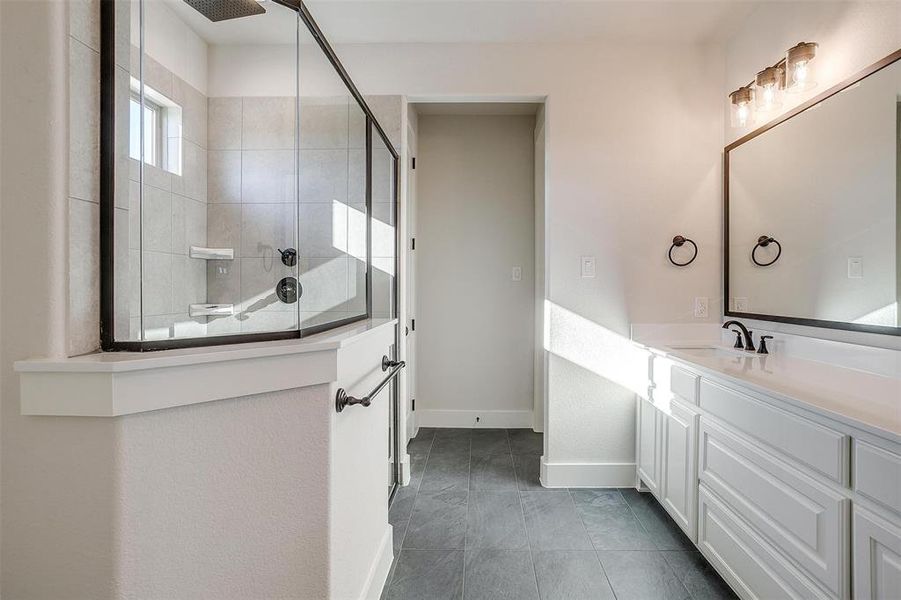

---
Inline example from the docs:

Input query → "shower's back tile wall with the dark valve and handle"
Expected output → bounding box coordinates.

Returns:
[207,97,366,335]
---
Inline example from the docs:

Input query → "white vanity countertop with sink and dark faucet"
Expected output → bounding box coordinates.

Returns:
[634,339,901,438]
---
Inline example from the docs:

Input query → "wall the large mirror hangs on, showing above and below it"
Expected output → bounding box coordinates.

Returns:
[720,1,901,349]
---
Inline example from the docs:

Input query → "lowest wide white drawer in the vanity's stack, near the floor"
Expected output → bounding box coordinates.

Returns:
[698,485,829,600]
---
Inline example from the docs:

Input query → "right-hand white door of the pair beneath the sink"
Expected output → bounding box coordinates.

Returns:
[660,402,698,542]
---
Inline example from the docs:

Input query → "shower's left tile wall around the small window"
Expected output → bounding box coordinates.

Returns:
[127,48,208,340]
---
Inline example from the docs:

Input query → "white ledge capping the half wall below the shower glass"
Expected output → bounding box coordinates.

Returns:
[15,319,397,417]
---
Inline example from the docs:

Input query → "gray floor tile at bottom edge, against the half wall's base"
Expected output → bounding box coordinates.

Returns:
[387,550,463,600]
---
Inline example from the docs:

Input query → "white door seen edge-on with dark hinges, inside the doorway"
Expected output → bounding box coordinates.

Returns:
[401,126,416,439]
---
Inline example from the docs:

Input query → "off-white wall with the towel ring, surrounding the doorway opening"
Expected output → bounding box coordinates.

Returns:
[210,39,723,484]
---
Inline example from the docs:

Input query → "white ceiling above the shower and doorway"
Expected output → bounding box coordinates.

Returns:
[162,0,759,44]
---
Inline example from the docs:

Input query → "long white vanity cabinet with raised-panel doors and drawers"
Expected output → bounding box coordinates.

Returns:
[636,356,901,600]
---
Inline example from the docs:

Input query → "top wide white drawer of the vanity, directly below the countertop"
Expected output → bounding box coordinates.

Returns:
[699,379,850,485]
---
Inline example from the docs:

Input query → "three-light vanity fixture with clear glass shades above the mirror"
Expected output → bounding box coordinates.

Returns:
[729,42,818,128]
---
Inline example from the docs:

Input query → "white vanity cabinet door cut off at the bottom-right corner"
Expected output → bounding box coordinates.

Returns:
[854,506,901,600]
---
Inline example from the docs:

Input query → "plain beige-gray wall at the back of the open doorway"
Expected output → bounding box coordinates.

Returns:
[416,114,535,427]
